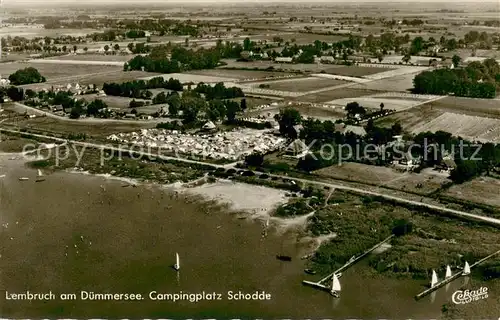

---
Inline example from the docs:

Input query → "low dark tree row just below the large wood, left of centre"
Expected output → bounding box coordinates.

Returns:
[102,77,183,99]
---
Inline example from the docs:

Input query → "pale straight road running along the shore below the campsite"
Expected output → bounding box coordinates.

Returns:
[0,128,500,226]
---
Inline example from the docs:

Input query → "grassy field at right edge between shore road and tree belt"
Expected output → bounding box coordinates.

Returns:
[445,177,500,207]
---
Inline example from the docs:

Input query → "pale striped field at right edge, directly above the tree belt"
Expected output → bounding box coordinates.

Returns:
[411,112,500,143]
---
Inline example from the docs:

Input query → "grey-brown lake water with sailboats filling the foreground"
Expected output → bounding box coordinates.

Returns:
[0,156,464,319]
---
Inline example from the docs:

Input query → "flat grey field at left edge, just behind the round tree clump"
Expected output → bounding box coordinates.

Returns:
[1,62,123,81]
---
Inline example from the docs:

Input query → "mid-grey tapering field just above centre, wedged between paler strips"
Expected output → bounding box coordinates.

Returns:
[255,77,349,92]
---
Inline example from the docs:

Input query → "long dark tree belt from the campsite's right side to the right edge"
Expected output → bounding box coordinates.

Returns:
[276,108,500,183]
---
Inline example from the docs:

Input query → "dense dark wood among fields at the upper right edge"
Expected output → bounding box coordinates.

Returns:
[413,59,500,98]
